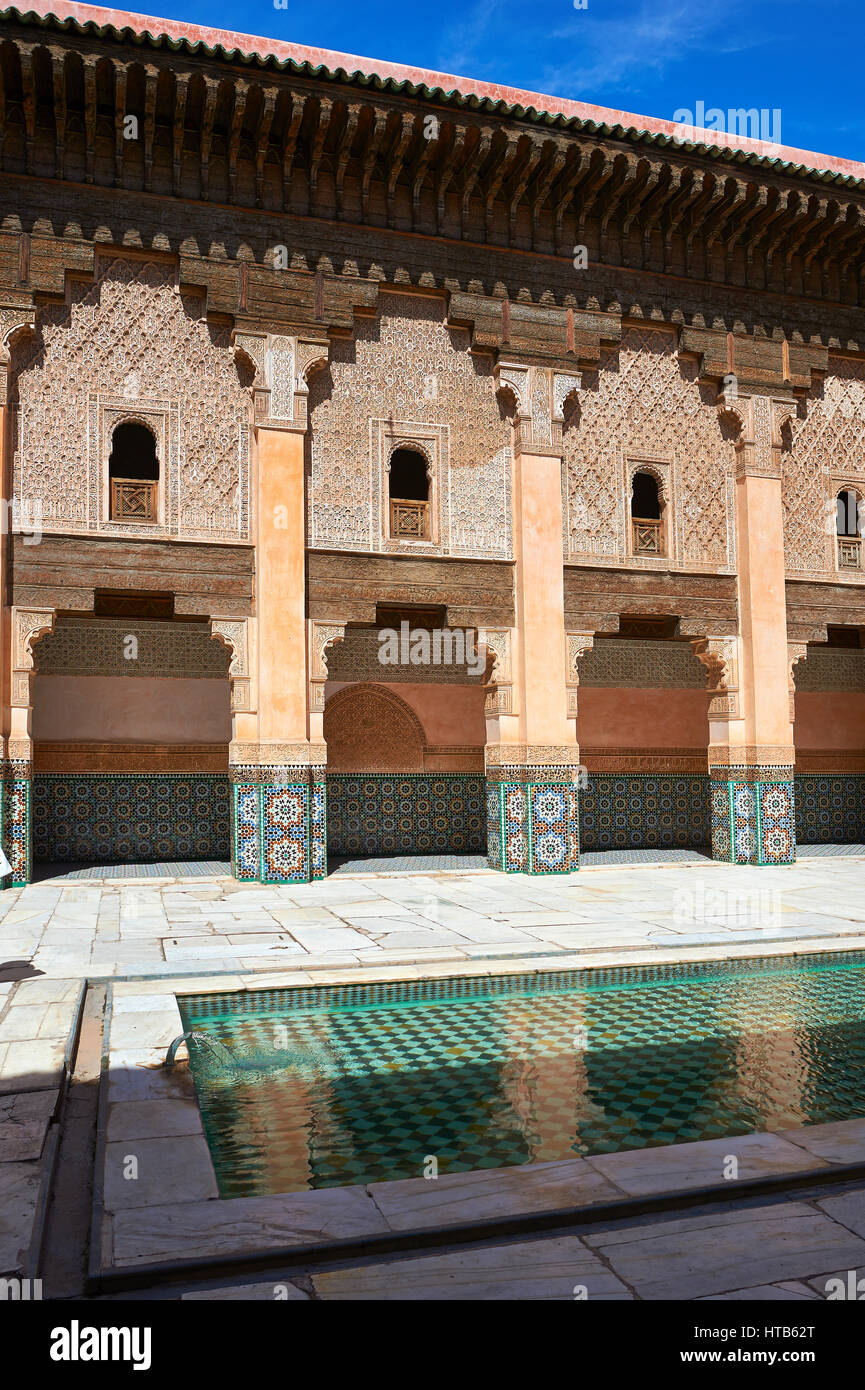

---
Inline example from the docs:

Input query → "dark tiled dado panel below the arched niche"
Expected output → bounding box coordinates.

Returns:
[327,773,487,855]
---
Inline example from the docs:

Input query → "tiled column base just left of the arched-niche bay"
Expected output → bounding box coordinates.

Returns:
[231,766,327,883]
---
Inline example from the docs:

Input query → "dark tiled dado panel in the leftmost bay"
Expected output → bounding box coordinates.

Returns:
[33,773,231,863]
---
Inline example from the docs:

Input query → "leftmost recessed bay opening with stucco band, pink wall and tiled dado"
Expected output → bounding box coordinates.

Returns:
[31,614,231,873]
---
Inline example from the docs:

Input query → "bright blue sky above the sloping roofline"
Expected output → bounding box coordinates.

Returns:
[154,0,865,160]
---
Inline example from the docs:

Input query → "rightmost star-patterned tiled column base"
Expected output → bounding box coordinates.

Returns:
[711,767,795,865]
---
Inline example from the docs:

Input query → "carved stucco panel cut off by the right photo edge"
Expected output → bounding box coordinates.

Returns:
[782,357,865,578]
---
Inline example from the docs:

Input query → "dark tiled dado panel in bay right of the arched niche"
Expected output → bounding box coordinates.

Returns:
[580,773,711,849]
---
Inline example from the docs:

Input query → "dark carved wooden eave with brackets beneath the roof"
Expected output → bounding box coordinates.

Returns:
[0,11,865,304]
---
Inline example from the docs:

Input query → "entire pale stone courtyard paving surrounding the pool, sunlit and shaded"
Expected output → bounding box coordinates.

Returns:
[0,853,865,1301]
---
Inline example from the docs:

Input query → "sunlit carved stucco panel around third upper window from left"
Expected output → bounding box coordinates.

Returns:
[563,328,734,570]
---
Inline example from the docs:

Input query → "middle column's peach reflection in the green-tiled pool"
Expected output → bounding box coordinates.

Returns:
[501,991,599,1163]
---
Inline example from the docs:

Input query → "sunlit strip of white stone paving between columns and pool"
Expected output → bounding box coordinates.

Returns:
[0,856,865,984]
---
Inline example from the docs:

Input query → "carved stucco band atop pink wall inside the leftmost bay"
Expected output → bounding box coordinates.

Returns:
[33,617,229,680]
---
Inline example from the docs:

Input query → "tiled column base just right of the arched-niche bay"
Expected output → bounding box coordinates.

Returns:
[487,767,580,873]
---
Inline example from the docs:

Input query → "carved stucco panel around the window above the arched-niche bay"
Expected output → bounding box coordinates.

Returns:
[309,291,512,559]
